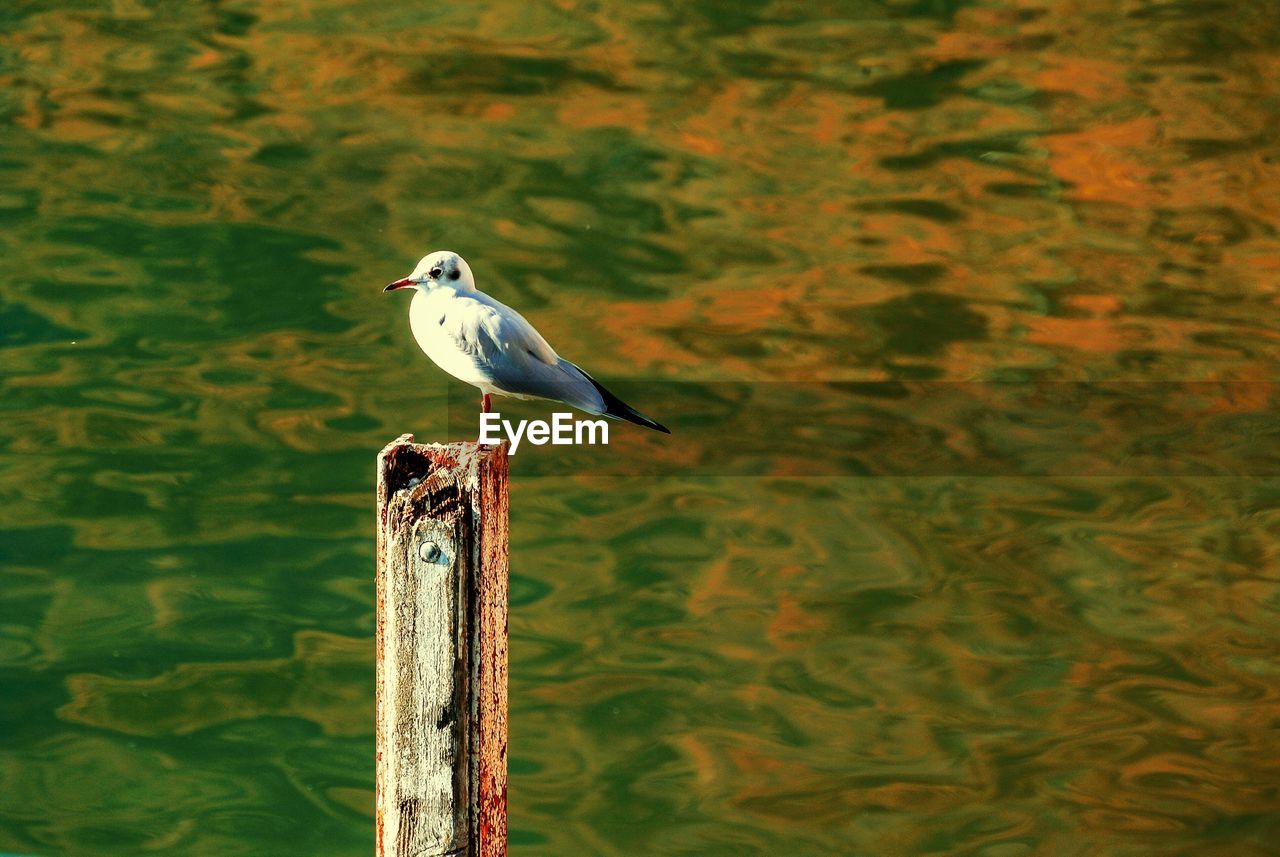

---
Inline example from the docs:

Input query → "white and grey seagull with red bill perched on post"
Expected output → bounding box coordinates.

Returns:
[383,249,671,435]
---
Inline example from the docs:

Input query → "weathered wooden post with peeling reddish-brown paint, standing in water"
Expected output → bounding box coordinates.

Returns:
[376,435,507,857]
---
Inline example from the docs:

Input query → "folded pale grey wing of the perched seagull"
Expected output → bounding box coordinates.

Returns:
[449,294,605,413]
